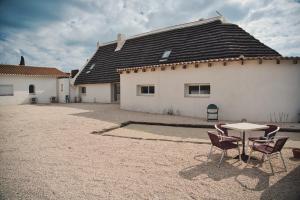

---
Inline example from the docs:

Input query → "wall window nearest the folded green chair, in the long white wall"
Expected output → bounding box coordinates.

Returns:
[185,83,210,97]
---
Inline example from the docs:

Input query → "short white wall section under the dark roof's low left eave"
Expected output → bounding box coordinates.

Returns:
[79,83,111,103]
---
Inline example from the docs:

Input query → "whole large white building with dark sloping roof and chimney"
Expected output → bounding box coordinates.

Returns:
[75,17,300,122]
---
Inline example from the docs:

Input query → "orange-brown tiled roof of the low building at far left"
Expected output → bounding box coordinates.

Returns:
[0,64,68,77]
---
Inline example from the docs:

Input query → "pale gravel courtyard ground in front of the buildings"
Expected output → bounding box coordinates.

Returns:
[0,104,300,200]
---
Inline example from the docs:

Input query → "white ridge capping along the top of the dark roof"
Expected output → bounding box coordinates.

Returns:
[99,16,223,47]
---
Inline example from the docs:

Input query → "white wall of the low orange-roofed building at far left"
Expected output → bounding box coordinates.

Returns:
[0,75,57,105]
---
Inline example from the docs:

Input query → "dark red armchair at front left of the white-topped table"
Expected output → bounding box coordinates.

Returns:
[207,131,241,167]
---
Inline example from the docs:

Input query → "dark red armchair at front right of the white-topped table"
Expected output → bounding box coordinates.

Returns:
[247,137,288,174]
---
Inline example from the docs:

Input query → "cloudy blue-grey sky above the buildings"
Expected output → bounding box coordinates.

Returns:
[0,0,300,72]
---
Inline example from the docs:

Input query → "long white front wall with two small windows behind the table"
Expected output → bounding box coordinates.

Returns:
[120,61,300,122]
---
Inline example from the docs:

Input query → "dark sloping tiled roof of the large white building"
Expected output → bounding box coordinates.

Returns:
[75,20,280,84]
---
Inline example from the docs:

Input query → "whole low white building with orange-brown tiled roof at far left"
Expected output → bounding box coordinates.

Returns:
[0,64,69,105]
